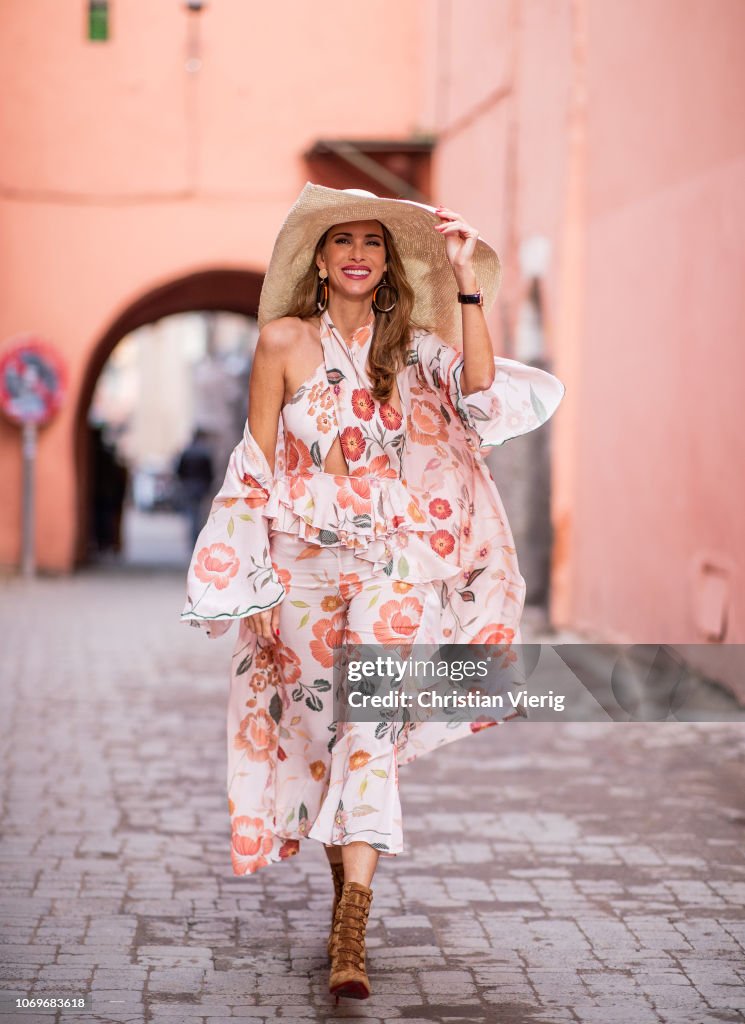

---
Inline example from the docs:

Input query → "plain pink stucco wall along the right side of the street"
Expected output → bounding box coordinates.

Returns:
[430,0,745,643]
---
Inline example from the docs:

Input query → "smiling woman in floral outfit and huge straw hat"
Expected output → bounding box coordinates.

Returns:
[182,183,564,998]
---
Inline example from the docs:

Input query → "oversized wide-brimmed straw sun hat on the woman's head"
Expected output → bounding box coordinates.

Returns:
[259,181,500,348]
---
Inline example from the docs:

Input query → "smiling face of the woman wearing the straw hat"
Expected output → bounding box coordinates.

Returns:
[315,220,387,298]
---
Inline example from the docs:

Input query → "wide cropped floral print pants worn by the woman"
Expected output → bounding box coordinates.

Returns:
[261,532,434,855]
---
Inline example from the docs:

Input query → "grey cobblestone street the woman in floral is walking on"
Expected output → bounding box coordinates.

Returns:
[0,570,745,1024]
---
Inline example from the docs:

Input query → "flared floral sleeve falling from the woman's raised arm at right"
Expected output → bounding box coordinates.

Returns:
[415,334,566,447]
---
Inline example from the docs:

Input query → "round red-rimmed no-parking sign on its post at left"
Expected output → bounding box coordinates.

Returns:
[0,335,65,577]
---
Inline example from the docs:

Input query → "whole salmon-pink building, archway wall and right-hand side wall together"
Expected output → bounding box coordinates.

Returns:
[0,0,745,659]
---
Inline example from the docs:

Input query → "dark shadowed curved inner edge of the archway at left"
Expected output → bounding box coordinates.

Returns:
[75,270,264,566]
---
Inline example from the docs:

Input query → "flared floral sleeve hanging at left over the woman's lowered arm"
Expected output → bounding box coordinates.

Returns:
[181,423,286,637]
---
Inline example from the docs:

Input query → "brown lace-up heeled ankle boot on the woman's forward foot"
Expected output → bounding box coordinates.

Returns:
[328,882,373,1002]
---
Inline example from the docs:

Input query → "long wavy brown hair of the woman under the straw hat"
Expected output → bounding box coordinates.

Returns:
[283,224,424,401]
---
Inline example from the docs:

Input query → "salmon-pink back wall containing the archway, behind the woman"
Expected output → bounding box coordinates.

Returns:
[0,0,422,570]
